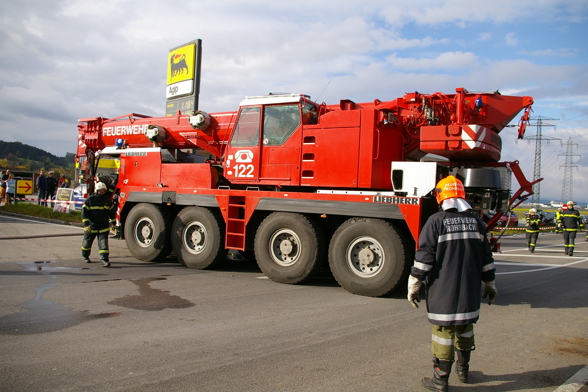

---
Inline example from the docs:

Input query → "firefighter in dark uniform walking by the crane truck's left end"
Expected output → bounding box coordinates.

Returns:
[82,182,115,267]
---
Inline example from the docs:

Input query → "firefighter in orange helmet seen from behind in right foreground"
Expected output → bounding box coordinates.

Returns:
[408,176,498,391]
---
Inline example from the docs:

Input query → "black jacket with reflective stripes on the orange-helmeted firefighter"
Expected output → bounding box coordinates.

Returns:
[411,210,496,326]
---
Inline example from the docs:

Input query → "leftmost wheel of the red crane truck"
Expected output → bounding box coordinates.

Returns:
[125,203,171,261]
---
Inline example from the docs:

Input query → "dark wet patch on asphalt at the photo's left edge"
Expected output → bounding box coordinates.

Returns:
[0,283,121,335]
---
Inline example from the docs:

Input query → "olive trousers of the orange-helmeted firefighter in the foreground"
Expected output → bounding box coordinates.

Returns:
[431,324,476,361]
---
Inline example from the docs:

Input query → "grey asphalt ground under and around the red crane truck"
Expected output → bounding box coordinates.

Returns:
[0,215,588,392]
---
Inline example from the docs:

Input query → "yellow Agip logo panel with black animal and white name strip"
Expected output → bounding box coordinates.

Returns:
[166,44,196,98]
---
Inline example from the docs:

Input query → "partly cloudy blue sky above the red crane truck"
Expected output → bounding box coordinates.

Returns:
[0,0,588,202]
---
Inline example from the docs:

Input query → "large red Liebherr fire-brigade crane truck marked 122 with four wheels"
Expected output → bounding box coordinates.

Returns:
[76,88,534,296]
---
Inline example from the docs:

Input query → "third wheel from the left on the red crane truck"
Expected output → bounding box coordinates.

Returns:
[255,212,326,284]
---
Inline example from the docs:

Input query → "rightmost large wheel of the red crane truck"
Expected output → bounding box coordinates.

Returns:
[329,218,409,297]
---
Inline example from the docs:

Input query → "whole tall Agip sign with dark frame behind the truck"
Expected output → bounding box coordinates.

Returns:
[165,39,202,116]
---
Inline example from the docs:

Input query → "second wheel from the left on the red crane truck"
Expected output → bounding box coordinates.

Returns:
[172,207,227,269]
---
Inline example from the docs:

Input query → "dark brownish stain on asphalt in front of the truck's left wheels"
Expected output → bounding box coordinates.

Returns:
[108,278,194,310]
